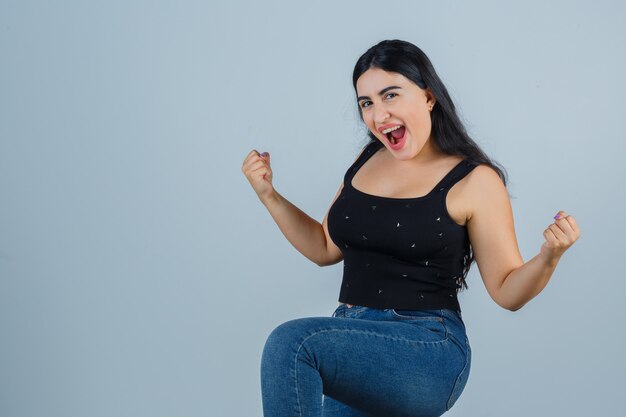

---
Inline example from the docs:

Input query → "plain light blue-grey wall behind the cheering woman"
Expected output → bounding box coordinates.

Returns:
[0,0,626,417]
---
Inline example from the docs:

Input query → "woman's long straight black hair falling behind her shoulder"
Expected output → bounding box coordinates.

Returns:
[352,39,507,288]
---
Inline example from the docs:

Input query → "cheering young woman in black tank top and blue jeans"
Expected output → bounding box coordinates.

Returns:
[242,40,580,417]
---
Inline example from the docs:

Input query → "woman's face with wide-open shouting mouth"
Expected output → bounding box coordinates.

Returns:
[356,68,435,160]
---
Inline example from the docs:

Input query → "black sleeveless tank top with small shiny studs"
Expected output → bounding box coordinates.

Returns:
[328,141,476,311]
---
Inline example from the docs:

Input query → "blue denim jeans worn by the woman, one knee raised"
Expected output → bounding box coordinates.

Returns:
[261,304,471,417]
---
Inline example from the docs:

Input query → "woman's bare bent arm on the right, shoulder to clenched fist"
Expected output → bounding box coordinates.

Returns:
[467,165,580,311]
